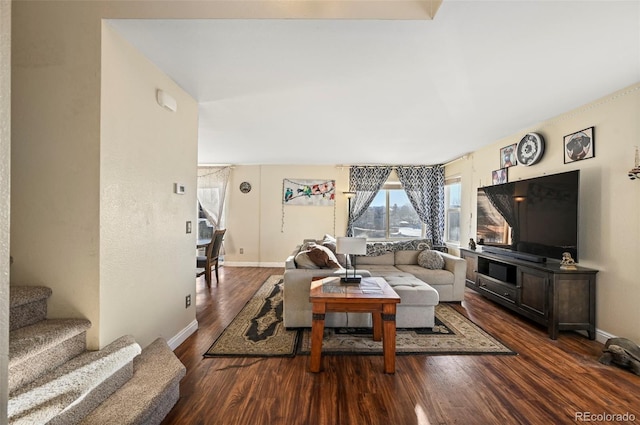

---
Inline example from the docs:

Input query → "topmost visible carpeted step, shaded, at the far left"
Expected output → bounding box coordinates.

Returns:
[9,286,51,331]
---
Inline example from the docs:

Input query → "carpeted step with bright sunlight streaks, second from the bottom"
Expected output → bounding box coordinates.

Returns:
[8,335,141,425]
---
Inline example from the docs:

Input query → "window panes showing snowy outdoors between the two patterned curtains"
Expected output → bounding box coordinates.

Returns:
[353,182,424,239]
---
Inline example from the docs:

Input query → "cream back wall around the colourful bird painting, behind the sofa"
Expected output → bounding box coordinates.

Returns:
[225,165,349,266]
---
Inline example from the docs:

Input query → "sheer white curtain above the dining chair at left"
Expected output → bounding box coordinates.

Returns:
[197,167,231,235]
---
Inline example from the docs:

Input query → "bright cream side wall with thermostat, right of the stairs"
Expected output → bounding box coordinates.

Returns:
[100,24,198,346]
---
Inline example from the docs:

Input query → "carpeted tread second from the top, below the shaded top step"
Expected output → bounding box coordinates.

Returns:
[9,319,91,369]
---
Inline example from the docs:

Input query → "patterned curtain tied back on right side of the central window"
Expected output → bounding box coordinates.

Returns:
[396,165,445,246]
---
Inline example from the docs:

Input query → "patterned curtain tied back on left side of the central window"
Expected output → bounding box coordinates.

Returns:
[347,166,392,236]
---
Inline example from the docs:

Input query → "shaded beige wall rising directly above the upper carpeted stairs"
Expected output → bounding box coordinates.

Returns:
[11,2,100,347]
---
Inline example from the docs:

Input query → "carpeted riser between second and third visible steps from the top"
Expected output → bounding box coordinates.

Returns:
[9,332,87,393]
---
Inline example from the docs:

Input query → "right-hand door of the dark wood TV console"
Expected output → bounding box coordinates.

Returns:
[517,267,549,318]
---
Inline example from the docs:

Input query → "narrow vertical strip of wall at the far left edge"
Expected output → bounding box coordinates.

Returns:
[0,0,11,423]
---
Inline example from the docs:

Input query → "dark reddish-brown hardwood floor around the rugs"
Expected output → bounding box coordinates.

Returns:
[163,267,640,425]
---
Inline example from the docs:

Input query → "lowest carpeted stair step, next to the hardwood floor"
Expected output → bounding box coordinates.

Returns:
[81,338,186,425]
